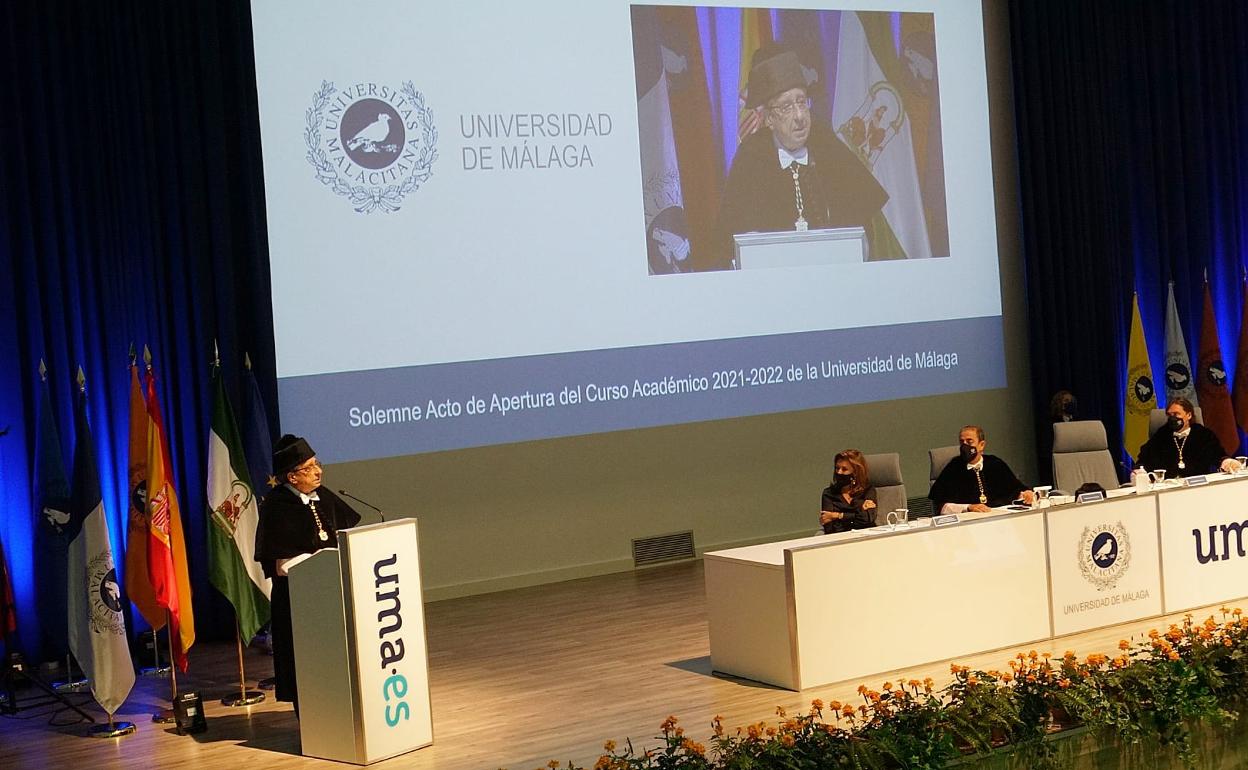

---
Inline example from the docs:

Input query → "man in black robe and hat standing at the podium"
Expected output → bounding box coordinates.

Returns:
[256,434,359,716]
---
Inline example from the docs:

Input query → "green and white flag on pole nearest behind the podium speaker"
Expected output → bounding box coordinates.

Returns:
[208,366,272,644]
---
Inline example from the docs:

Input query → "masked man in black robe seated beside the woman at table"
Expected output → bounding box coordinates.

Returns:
[927,426,1035,513]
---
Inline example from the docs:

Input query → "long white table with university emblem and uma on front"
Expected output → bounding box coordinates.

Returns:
[704,474,1248,690]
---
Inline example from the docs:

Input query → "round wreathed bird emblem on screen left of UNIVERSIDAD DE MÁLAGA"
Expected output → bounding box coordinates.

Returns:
[303,80,438,213]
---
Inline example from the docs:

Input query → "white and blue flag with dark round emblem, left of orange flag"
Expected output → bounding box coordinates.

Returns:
[65,369,135,714]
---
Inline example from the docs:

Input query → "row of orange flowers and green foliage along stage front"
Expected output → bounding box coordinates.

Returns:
[531,608,1248,770]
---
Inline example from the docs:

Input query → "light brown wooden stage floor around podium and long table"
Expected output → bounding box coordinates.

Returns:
[0,562,1243,770]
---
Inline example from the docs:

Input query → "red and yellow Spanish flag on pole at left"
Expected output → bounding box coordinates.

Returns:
[147,367,195,671]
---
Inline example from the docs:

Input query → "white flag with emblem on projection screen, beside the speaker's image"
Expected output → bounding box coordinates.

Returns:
[832,12,932,260]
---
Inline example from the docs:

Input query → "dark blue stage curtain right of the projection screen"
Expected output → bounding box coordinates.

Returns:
[1010,0,1248,473]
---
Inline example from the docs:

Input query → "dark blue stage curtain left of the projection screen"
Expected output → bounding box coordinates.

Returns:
[0,0,278,661]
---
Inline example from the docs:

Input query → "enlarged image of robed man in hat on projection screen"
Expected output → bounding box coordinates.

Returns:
[716,49,889,267]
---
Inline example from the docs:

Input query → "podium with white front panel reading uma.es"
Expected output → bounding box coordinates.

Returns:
[290,519,433,765]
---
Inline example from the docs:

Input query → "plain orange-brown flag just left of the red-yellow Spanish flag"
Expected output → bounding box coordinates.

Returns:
[126,356,165,630]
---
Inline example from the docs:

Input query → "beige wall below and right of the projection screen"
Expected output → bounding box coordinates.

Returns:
[326,1,1036,600]
